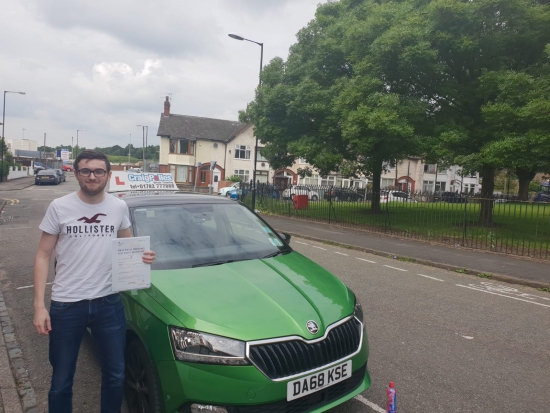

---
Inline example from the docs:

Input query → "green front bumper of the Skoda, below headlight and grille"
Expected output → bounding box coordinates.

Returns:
[156,326,370,413]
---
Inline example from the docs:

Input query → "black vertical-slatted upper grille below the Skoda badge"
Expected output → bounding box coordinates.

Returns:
[249,318,361,380]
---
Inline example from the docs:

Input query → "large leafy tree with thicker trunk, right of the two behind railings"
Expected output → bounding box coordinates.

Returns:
[370,0,550,226]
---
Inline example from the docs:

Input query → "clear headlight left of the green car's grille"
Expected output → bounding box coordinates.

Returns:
[170,327,249,366]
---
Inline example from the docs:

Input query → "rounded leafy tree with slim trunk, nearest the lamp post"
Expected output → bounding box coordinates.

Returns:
[240,1,425,212]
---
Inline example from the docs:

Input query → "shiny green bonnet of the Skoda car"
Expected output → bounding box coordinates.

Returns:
[146,252,354,341]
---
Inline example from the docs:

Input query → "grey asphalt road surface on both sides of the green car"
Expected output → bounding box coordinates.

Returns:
[0,176,550,413]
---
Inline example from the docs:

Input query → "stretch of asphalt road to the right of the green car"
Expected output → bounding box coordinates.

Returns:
[292,239,550,413]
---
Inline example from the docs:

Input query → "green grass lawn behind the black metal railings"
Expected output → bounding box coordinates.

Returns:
[250,197,550,259]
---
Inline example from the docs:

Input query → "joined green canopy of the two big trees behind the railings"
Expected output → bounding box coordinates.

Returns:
[241,0,550,219]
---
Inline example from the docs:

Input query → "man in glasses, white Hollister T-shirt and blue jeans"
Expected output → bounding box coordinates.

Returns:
[34,150,155,413]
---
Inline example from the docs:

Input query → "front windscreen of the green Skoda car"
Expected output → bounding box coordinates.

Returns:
[131,200,290,270]
